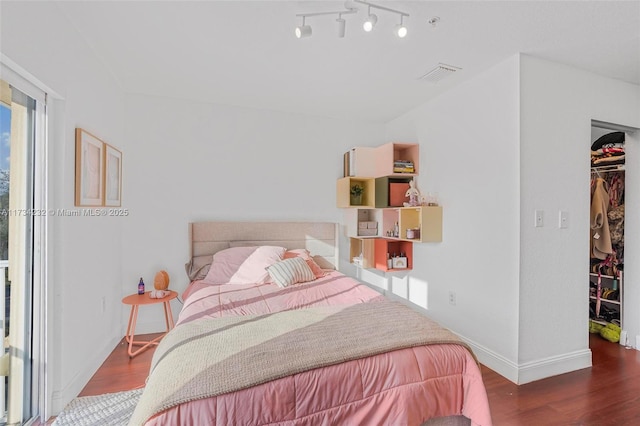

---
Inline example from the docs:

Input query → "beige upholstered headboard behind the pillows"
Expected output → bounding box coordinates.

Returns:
[186,222,338,279]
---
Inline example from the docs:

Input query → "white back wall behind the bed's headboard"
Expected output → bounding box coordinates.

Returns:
[121,95,384,332]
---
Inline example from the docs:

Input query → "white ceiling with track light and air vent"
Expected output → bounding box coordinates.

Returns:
[57,0,640,122]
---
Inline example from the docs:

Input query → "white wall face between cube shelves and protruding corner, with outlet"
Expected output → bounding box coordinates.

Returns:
[387,58,520,378]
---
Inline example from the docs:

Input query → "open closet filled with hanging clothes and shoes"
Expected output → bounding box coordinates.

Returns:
[589,127,627,344]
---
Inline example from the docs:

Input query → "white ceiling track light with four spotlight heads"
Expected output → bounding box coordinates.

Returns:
[295,0,409,38]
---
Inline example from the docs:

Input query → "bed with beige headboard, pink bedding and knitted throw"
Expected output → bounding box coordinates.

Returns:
[130,222,491,426]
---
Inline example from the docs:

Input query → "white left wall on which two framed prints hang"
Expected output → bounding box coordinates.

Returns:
[0,2,127,414]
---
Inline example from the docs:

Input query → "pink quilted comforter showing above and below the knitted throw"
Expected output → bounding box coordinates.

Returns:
[147,271,491,426]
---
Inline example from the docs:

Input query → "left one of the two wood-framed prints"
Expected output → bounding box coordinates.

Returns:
[75,128,105,206]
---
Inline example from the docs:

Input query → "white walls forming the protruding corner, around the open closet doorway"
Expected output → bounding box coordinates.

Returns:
[383,56,640,383]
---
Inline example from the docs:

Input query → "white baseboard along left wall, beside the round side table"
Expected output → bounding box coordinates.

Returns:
[50,336,122,416]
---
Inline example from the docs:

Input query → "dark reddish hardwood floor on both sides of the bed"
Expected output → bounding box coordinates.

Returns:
[40,335,640,426]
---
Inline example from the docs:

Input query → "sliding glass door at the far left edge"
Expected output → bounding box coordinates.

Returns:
[0,81,38,425]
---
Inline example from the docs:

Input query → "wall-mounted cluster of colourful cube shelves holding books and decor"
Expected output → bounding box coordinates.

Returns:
[336,142,442,272]
